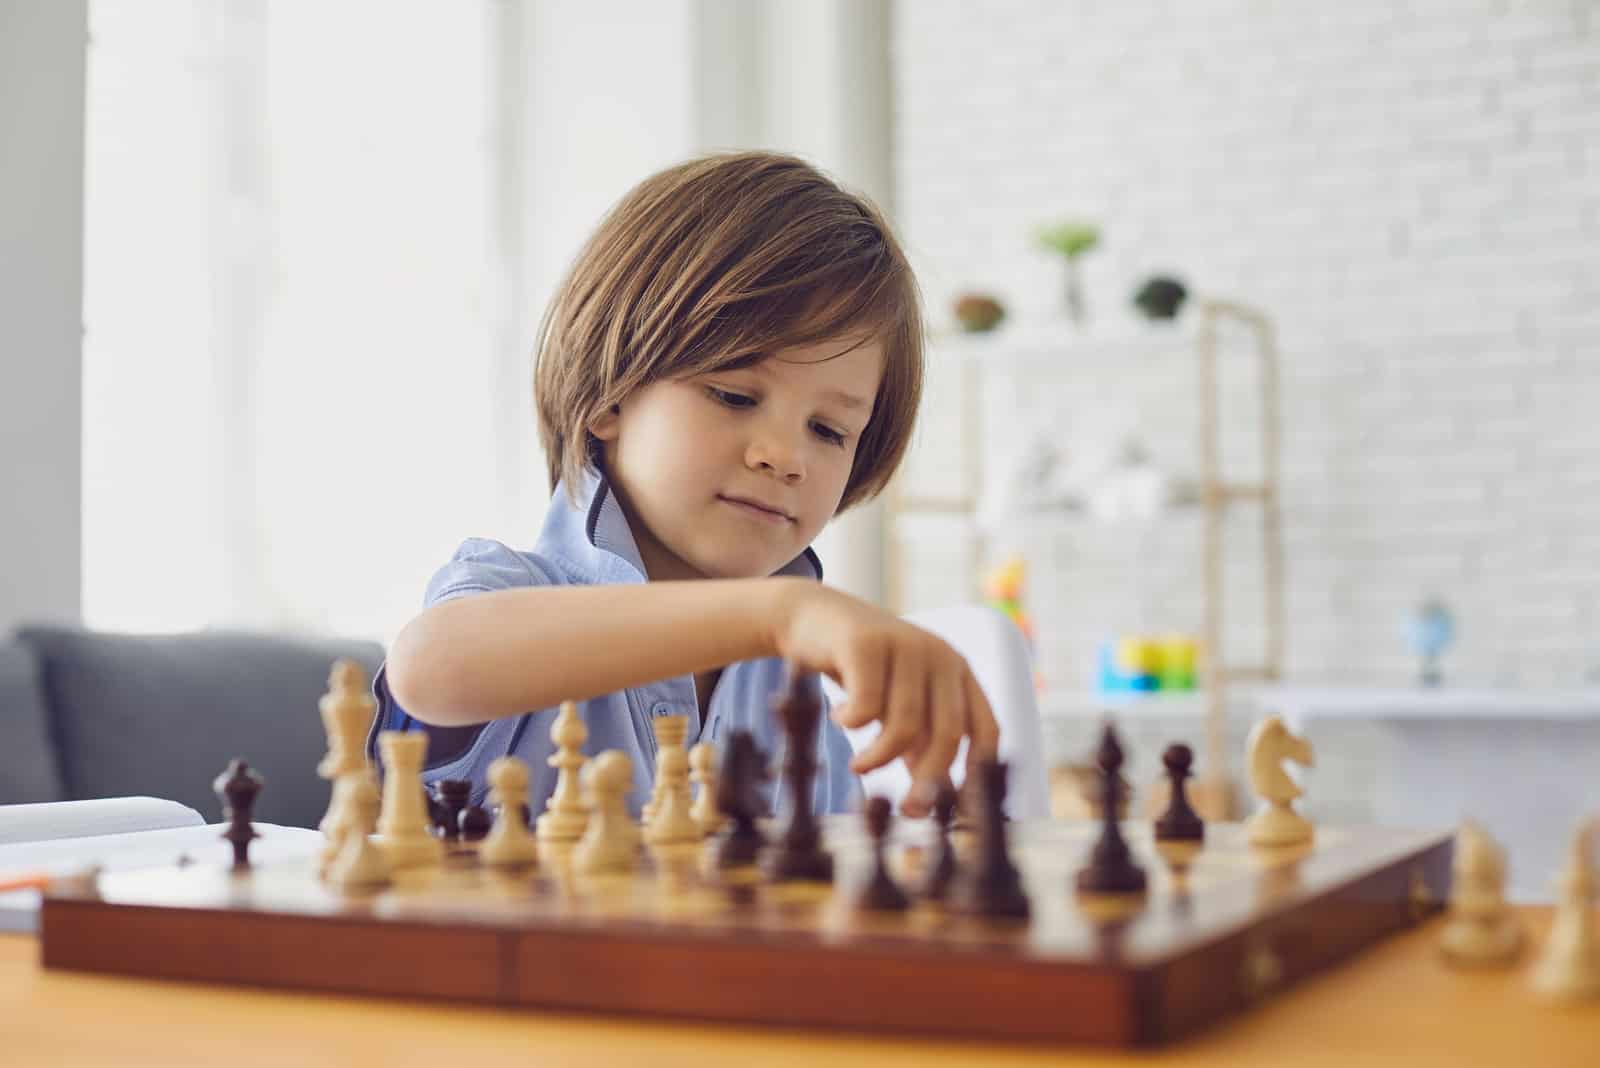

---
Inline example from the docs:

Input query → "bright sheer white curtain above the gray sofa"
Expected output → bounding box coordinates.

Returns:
[83,0,546,640]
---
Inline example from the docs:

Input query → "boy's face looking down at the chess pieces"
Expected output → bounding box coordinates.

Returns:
[590,339,883,580]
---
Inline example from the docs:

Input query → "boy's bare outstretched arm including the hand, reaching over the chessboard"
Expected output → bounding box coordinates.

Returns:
[387,577,1000,815]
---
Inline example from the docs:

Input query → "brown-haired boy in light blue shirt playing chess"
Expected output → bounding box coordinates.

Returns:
[373,152,997,815]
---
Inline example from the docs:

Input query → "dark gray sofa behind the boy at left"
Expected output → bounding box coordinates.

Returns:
[0,627,382,827]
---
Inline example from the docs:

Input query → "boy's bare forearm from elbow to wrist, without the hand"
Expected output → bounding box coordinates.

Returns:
[387,579,814,726]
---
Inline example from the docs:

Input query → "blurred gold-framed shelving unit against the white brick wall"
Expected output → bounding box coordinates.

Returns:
[888,301,1285,817]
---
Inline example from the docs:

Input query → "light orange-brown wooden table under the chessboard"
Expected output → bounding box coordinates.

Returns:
[0,910,1600,1068]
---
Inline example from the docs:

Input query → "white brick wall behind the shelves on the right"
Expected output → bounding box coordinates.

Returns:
[893,0,1600,686]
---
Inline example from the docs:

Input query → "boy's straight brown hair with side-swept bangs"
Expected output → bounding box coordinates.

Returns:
[533,152,923,512]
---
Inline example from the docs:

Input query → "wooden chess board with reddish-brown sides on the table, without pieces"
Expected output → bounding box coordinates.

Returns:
[40,817,1451,1046]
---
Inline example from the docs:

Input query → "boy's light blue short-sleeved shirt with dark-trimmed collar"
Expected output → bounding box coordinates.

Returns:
[366,472,859,815]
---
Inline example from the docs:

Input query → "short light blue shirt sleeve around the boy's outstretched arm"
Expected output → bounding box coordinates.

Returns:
[366,537,555,769]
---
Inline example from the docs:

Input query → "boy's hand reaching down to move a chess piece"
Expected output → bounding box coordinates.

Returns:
[774,580,1000,815]
